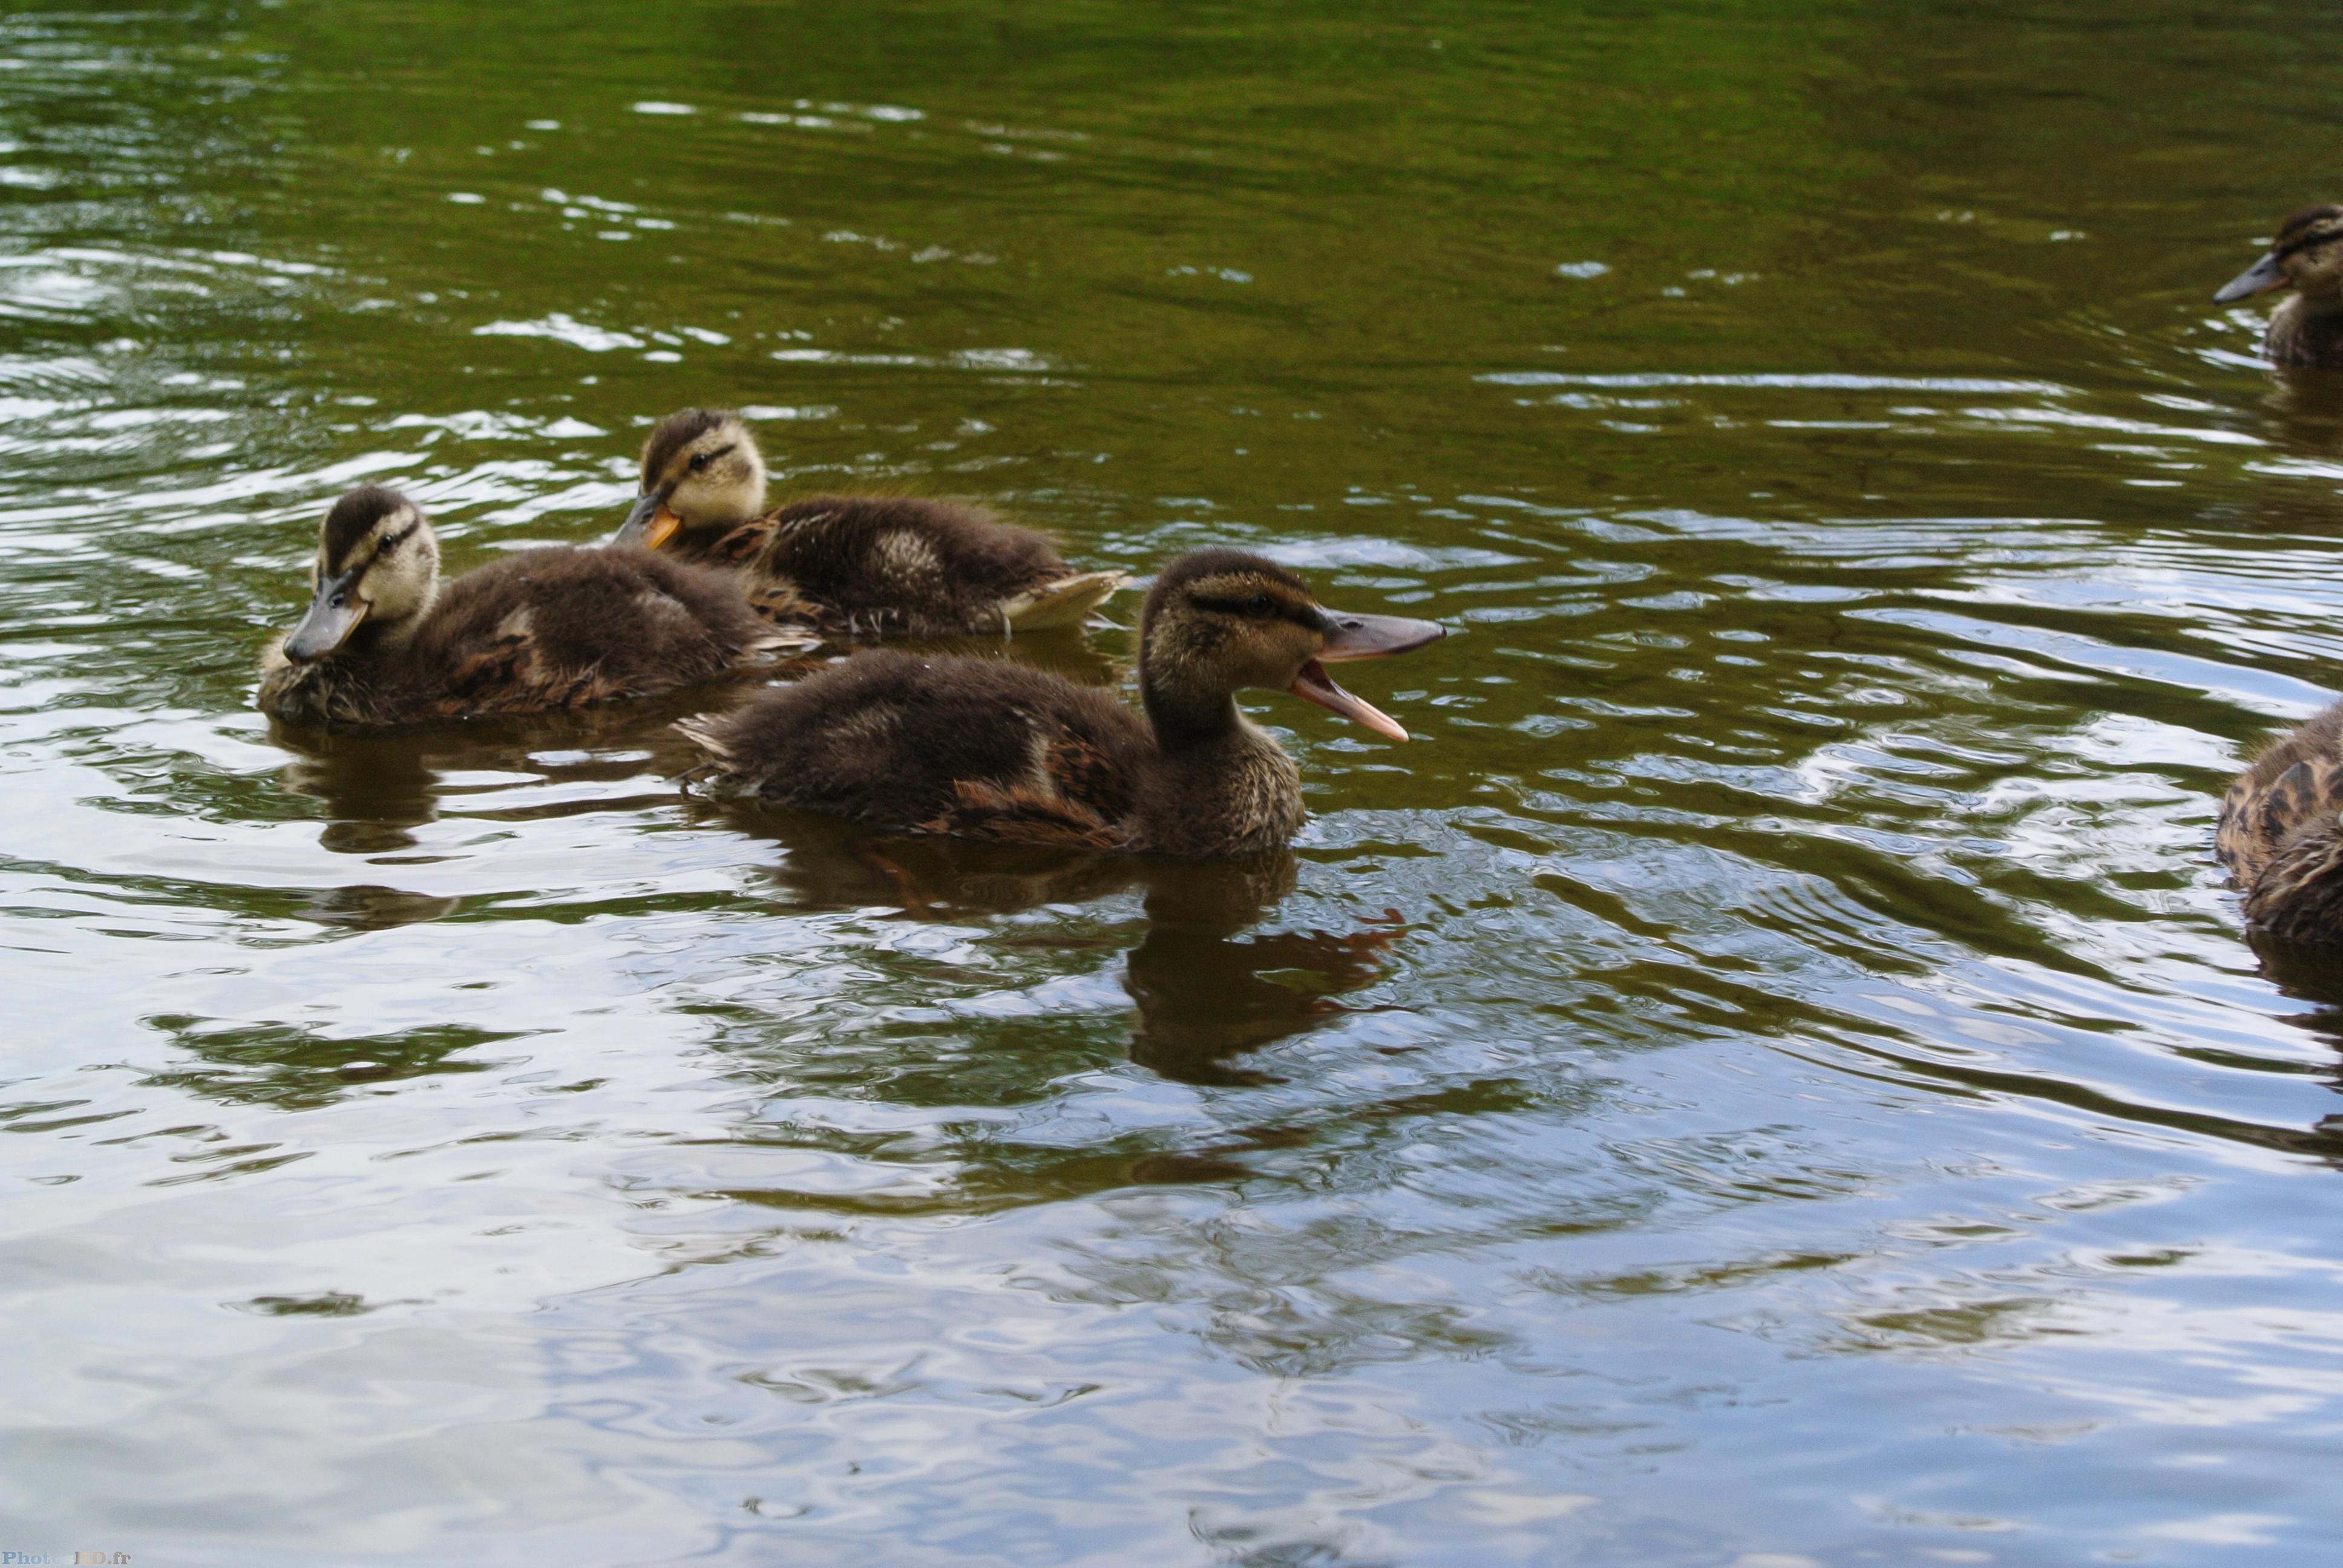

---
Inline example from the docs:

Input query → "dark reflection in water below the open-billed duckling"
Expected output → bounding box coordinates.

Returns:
[757,813,1406,1085]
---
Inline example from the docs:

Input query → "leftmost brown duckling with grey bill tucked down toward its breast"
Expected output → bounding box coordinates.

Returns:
[260,485,804,724]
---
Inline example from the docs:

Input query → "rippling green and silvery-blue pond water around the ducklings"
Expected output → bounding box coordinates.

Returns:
[0,0,2343,1568]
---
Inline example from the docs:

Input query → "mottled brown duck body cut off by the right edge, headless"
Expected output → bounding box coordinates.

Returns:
[2214,703,2343,947]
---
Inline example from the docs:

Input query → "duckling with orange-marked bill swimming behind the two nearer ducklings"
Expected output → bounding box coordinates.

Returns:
[616,408,1125,638]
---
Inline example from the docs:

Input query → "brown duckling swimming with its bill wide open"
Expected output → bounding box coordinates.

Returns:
[677,550,1446,855]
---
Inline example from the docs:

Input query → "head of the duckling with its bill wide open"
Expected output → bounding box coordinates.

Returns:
[1139,550,1448,740]
